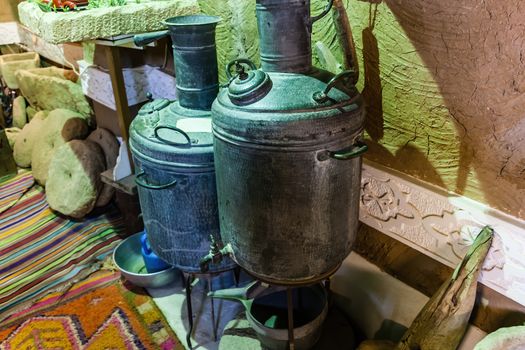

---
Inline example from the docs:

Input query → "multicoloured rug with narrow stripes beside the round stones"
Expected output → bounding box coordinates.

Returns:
[0,172,123,322]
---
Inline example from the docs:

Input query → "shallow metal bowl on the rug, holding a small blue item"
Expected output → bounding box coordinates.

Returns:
[113,232,179,288]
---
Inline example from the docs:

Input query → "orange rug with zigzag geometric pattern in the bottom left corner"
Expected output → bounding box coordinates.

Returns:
[0,271,184,350]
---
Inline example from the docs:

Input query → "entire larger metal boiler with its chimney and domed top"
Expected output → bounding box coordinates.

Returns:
[212,0,364,284]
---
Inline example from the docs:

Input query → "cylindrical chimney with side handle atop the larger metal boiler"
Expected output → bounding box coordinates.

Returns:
[256,0,333,73]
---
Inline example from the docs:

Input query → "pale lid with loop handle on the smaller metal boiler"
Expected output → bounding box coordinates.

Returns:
[130,99,213,168]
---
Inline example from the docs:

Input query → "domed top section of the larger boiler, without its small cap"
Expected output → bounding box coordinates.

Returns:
[212,69,364,147]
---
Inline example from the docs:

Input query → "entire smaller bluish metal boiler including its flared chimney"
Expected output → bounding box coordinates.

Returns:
[130,15,235,272]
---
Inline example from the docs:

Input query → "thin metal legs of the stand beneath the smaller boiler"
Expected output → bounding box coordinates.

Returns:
[181,266,241,349]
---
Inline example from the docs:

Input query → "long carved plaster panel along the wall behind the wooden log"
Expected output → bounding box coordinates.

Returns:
[359,162,525,305]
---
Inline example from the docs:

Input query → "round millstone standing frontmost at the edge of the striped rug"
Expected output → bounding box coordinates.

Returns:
[46,140,105,219]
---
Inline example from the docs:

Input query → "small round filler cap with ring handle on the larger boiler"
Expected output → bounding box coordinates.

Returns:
[228,70,272,106]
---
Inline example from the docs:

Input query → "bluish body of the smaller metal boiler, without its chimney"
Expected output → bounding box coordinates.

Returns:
[130,99,237,272]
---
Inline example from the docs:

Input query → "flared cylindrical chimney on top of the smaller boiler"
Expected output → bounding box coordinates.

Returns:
[164,15,220,110]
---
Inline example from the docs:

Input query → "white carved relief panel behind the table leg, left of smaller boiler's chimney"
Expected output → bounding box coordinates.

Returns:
[78,61,176,110]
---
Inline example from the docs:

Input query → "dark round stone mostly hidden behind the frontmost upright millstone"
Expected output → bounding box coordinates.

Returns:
[87,128,120,207]
